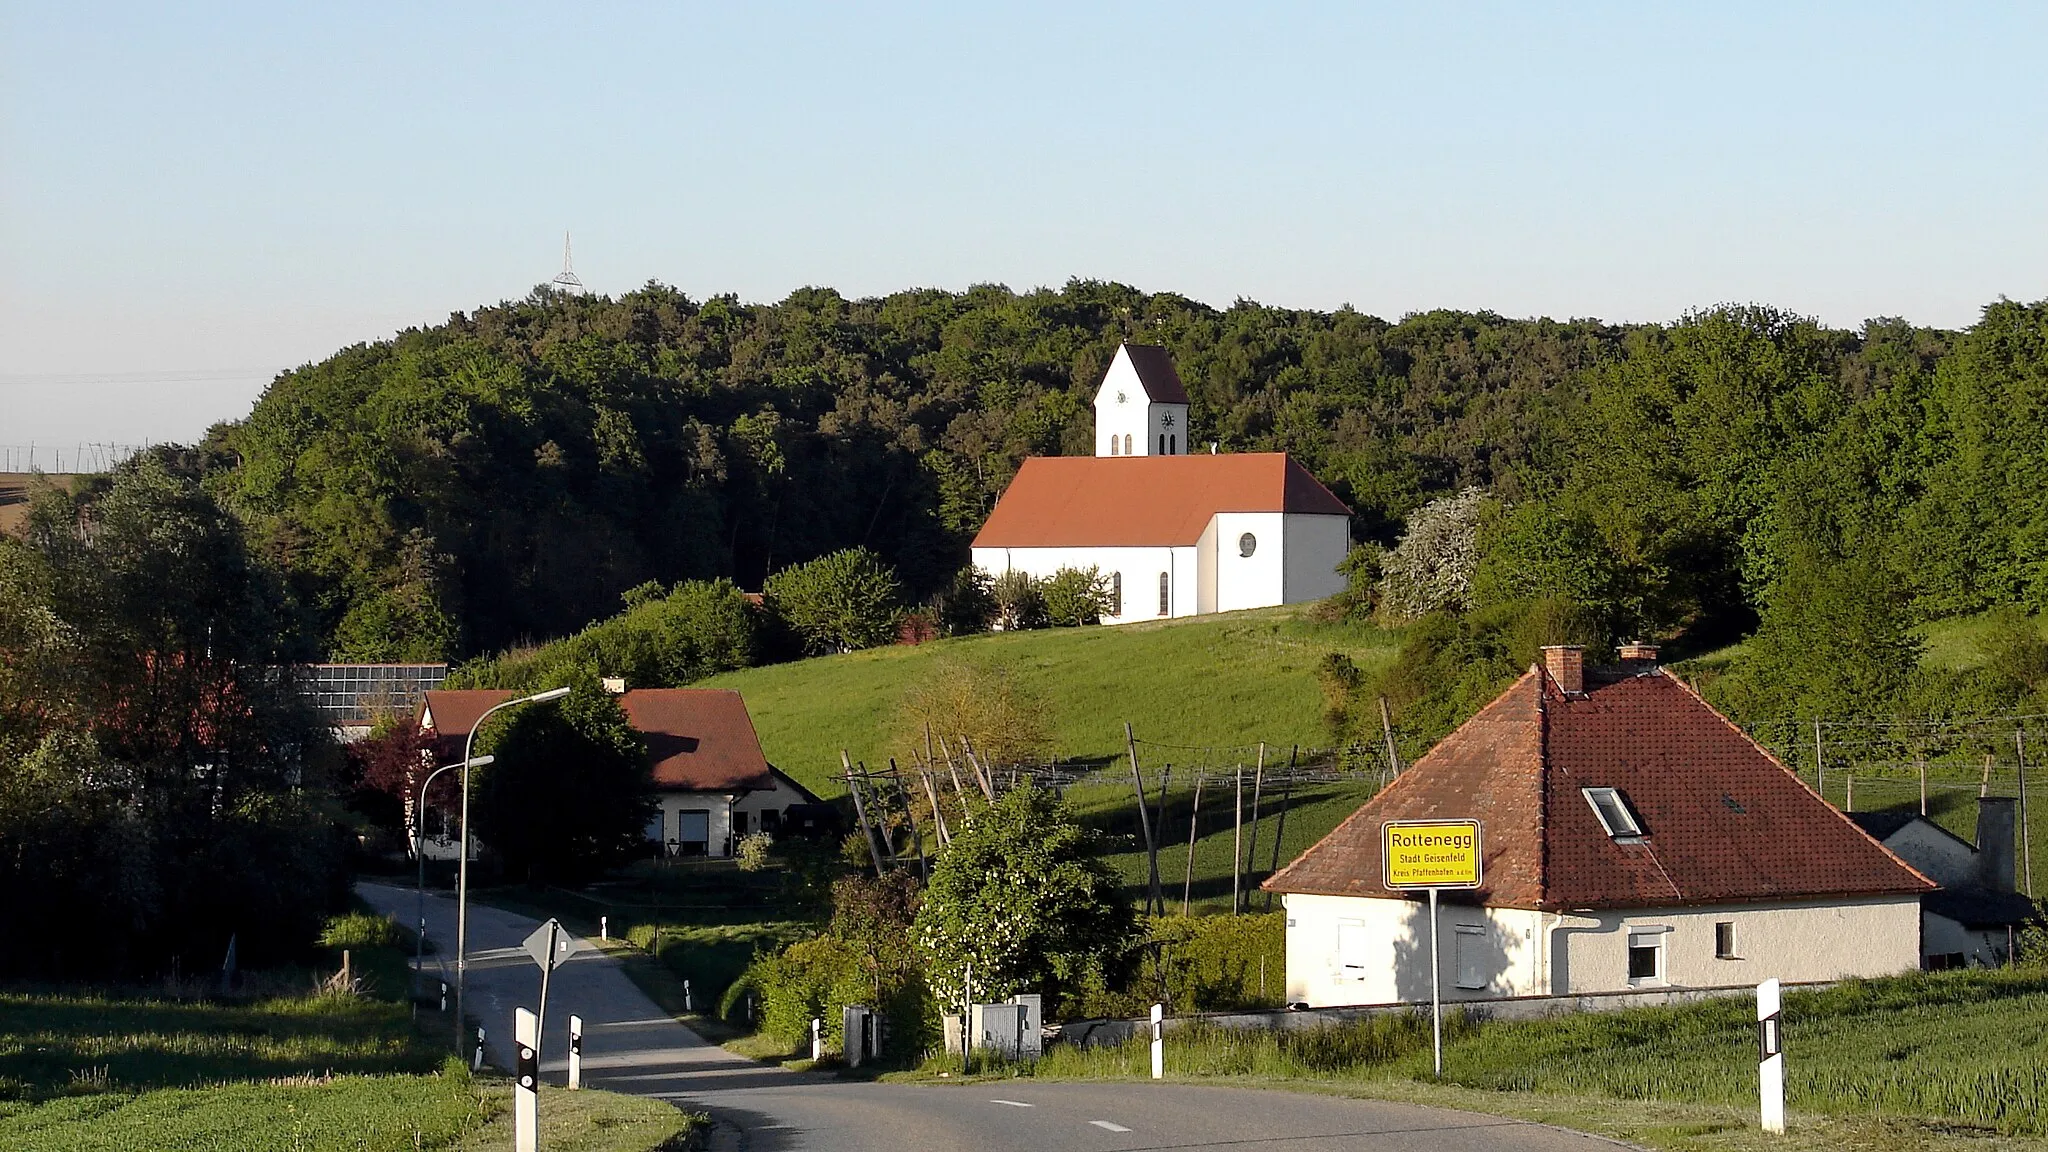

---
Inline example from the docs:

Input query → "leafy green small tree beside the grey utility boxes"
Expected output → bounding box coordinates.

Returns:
[915,781,1135,1011]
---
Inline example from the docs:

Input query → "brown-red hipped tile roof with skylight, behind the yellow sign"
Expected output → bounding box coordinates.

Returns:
[1266,666,1935,910]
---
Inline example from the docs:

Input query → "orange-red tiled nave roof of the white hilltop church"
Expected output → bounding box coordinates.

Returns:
[975,453,1352,547]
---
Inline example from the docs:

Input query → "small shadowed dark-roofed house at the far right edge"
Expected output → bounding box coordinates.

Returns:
[1849,795,2038,970]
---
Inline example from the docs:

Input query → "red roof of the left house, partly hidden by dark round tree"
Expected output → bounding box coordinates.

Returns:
[420,689,774,791]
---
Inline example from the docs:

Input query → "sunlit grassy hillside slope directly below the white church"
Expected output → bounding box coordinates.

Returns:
[700,607,1399,797]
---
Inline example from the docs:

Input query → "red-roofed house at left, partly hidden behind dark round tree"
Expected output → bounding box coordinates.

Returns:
[420,689,817,859]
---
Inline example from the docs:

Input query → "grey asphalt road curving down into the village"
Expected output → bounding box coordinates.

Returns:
[358,883,1614,1152]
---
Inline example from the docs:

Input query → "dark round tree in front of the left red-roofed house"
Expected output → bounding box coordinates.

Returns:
[471,668,653,883]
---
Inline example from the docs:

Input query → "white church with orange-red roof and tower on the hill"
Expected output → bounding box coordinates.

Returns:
[973,344,1352,623]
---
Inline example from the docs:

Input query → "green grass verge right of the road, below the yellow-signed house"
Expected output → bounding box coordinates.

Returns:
[915,970,2048,1148]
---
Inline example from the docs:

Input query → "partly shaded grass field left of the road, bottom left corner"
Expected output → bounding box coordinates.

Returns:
[0,916,688,1152]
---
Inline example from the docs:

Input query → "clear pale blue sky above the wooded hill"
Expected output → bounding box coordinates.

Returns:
[0,0,2048,446]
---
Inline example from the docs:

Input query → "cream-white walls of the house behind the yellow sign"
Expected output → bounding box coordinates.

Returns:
[1286,881,1925,1006]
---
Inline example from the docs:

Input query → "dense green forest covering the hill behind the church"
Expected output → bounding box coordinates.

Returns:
[195,281,2048,688]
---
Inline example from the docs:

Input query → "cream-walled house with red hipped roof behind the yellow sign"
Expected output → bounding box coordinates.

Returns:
[1266,646,1935,1006]
